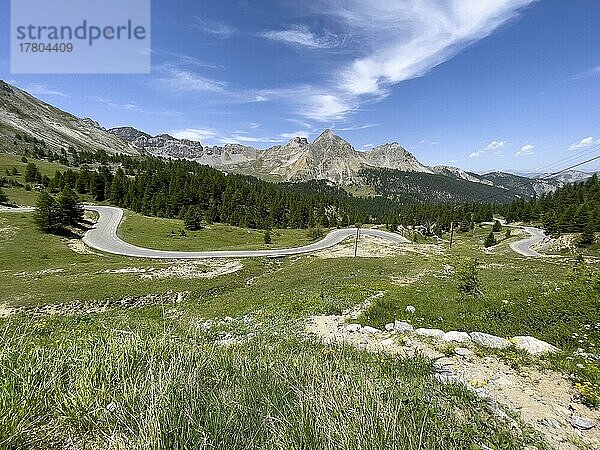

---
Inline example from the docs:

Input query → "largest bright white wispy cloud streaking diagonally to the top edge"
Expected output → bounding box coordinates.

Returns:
[303,0,535,121]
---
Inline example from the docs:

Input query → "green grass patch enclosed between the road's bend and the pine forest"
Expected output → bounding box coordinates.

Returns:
[118,213,322,251]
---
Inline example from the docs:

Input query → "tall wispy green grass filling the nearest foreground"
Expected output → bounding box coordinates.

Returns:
[0,320,536,449]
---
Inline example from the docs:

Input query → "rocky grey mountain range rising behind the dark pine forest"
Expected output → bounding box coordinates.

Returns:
[0,81,589,201]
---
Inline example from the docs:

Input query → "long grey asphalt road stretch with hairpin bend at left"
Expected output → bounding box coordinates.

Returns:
[83,206,409,259]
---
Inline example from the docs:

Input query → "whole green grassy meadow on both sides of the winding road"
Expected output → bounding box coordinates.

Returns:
[0,212,600,449]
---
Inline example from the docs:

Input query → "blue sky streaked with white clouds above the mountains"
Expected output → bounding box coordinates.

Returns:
[0,0,600,171]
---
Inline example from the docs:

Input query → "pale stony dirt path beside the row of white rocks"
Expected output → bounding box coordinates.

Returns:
[307,292,600,450]
